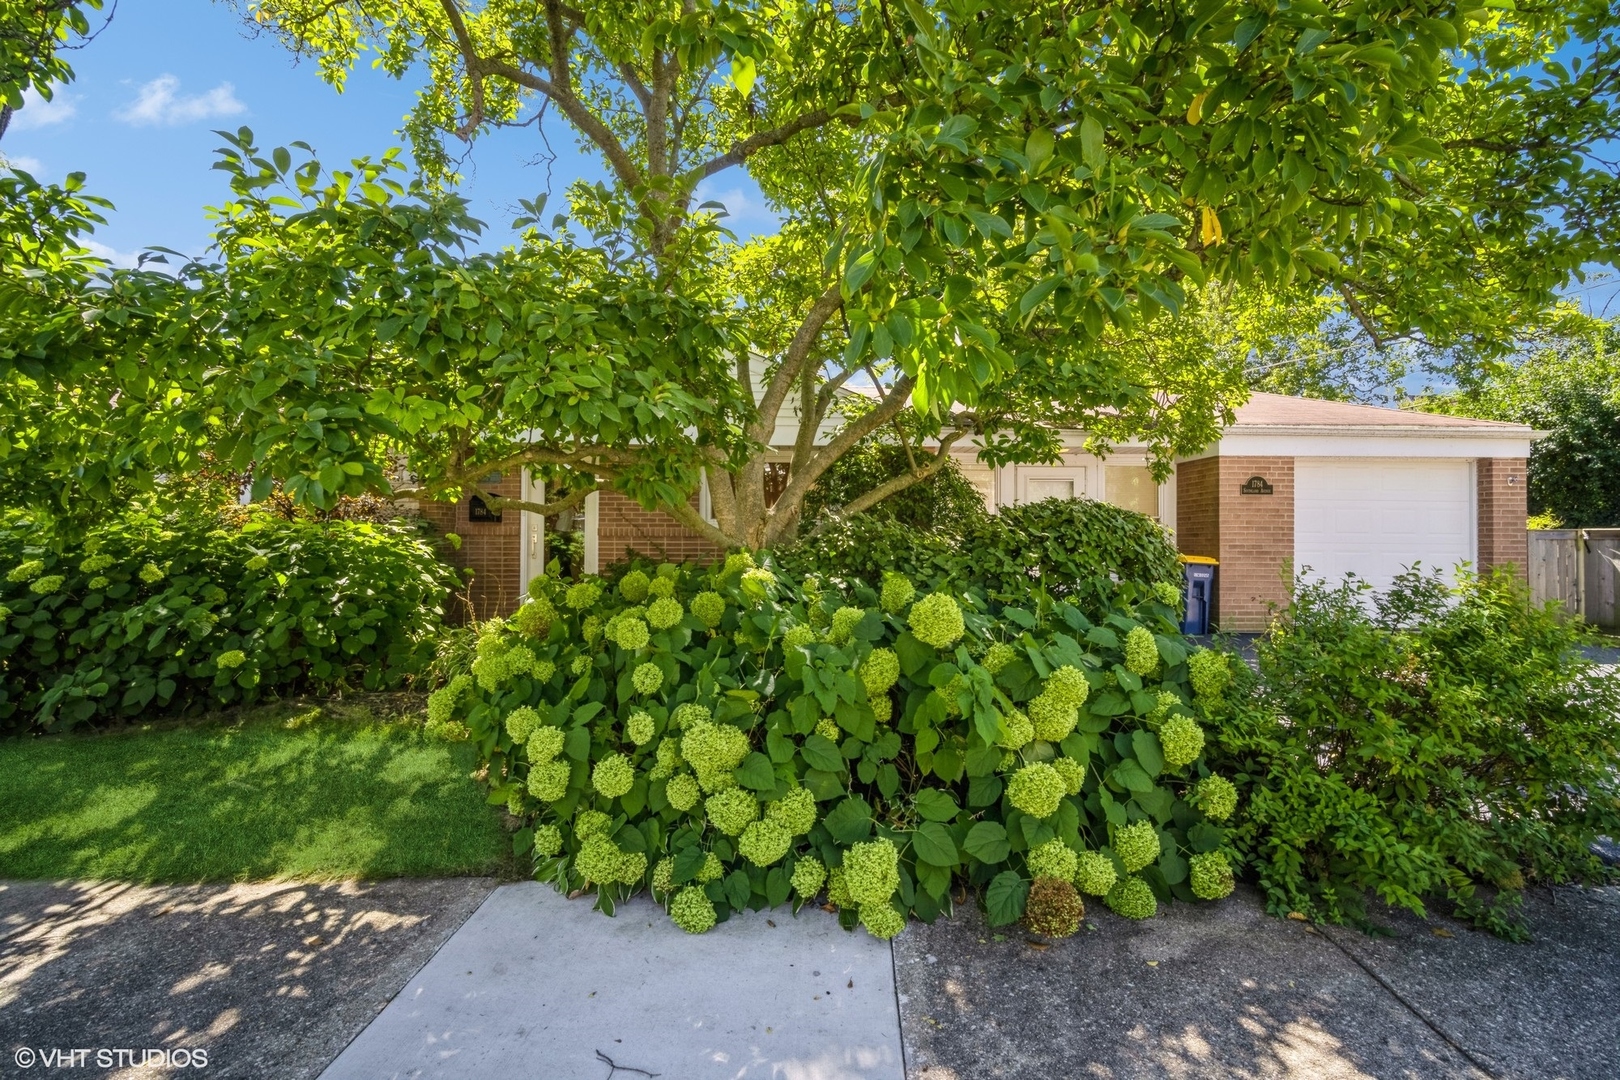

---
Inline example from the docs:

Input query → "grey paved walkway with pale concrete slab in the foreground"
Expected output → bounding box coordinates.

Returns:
[0,881,1620,1080]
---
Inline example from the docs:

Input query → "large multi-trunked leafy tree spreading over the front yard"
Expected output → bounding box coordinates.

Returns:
[3,0,1620,547]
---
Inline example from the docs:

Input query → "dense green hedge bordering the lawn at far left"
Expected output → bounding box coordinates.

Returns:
[0,512,455,732]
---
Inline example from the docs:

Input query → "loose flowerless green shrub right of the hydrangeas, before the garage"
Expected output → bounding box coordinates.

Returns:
[1197,573,1620,934]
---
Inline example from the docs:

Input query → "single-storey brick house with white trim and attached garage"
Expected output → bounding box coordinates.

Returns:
[424,393,1536,631]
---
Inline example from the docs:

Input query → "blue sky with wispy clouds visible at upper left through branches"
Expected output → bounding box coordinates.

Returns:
[0,0,774,262]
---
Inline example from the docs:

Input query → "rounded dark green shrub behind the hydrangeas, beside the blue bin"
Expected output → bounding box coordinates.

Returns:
[779,499,1181,614]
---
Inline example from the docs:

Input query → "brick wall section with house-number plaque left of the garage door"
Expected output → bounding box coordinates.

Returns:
[1211,457,1294,631]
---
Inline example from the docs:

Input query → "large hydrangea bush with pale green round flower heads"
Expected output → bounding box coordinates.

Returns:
[443,555,1236,938]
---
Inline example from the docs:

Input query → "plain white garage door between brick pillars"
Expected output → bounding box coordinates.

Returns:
[1294,458,1474,589]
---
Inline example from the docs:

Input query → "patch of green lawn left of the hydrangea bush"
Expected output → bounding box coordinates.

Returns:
[0,708,512,882]
